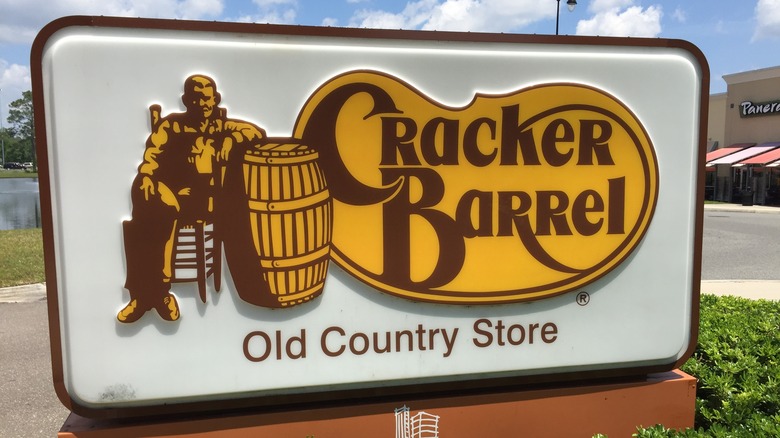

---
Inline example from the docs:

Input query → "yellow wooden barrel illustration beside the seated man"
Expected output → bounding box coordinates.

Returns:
[244,139,333,307]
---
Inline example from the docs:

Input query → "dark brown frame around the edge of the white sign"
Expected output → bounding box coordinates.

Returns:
[30,16,710,418]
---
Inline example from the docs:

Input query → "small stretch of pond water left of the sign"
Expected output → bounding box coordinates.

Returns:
[0,178,41,230]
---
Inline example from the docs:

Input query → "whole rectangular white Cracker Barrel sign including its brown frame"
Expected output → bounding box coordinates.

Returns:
[33,17,709,416]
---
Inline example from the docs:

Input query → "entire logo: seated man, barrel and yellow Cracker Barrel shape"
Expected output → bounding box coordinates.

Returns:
[122,71,658,323]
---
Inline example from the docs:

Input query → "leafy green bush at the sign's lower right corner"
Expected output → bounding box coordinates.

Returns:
[634,295,780,438]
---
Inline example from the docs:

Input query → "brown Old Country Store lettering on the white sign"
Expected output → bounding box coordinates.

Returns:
[244,318,558,362]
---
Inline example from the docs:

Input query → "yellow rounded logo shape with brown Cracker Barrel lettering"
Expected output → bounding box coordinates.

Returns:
[294,71,658,304]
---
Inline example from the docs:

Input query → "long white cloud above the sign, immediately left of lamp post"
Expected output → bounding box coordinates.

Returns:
[349,0,555,32]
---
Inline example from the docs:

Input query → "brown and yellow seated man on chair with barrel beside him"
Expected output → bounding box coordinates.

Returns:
[117,74,332,323]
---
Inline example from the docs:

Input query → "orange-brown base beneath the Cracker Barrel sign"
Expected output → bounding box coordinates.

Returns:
[58,370,696,438]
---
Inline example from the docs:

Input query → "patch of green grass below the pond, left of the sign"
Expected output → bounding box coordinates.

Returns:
[0,228,45,287]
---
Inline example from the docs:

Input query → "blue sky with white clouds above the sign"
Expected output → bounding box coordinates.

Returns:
[0,0,780,126]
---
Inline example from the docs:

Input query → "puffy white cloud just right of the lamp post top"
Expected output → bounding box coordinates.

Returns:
[577,1,663,37]
